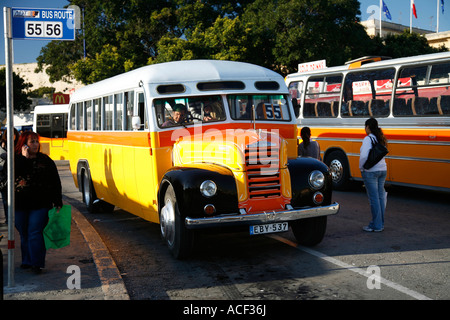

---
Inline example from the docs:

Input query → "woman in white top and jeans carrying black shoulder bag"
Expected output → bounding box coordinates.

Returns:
[359,118,387,232]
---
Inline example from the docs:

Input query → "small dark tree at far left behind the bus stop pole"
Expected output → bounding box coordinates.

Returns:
[0,68,33,112]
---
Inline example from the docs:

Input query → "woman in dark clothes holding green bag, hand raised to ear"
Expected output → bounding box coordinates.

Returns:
[15,132,62,273]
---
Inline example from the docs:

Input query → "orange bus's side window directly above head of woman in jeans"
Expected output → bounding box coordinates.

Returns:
[341,68,395,117]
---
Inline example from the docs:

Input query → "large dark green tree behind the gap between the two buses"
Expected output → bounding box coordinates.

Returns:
[242,0,371,74]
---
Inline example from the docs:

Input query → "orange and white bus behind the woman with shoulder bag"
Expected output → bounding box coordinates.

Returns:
[285,52,450,192]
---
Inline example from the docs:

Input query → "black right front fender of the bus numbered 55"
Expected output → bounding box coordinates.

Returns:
[288,157,332,208]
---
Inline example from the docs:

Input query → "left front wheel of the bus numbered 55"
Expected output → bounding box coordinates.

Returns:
[159,185,194,259]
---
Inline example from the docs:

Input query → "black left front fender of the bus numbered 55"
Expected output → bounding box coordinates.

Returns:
[158,164,238,218]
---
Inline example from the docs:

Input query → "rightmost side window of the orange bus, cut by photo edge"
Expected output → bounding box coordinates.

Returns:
[393,63,450,117]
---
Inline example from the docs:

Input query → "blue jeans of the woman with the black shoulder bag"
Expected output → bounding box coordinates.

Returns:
[361,171,387,230]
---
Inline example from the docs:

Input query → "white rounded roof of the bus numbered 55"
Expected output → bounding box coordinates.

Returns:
[71,60,287,101]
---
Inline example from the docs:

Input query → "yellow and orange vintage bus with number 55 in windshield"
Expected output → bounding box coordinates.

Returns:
[68,60,339,258]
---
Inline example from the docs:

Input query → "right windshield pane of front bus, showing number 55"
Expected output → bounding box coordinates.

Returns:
[227,95,291,121]
